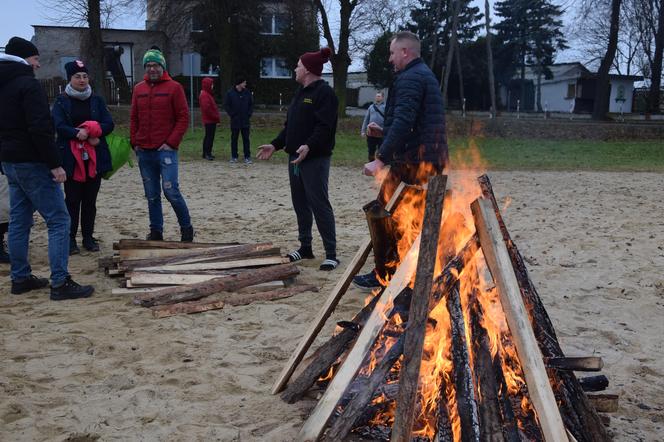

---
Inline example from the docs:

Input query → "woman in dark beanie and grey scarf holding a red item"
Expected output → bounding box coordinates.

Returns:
[53,60,114,255]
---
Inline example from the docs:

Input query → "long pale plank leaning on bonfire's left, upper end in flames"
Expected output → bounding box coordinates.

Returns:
[298,235,420,441]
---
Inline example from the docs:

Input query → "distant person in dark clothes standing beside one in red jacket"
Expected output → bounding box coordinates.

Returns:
[224,77,254,164]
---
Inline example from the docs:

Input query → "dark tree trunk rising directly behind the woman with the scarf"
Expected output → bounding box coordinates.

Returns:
[81,0,109,101]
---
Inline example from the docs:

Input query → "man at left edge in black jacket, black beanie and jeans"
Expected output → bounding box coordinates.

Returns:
[0,37,94,301]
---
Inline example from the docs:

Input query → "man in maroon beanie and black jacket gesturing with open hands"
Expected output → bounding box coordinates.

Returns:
[258,48,339,270]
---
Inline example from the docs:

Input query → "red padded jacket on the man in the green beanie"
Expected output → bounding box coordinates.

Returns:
[129,71,189,149]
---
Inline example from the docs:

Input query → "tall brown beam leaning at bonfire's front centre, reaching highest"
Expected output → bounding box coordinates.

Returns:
[390,175,447,442]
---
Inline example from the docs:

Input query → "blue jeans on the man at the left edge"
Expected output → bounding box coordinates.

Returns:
[2,163,70,286]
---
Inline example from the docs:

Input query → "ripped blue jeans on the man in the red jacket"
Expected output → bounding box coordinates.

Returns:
[136,149,191,232]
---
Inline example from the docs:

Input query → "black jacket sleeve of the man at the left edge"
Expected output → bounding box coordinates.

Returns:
[23,78,62,169]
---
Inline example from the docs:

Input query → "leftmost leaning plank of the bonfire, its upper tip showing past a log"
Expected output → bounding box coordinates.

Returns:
[272,183,406,394]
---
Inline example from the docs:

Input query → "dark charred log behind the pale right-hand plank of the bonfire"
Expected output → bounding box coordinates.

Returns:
[478,175,609,442]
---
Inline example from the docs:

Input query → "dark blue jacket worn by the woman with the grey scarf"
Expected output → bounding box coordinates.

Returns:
[51,94,115,178]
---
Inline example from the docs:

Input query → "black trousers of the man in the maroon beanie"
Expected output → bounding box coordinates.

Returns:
[288,155,337,258]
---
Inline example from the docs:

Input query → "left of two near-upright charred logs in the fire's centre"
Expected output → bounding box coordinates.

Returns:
[448,282,480,441]
